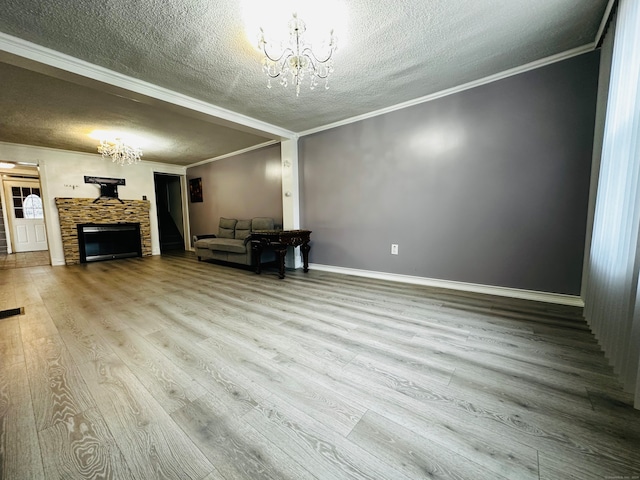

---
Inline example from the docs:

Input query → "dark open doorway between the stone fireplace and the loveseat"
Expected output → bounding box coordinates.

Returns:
[153,173,185,252]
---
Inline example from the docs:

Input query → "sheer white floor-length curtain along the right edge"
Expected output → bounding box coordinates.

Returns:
[584,0,640,408]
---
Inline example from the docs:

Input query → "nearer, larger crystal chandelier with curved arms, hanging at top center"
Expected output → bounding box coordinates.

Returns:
[258,13,337,97]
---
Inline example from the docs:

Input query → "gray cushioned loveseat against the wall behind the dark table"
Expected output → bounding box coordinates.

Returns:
[193,217,276,265]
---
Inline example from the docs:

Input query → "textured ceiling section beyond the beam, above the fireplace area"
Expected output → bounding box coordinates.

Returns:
[0,63,271,165]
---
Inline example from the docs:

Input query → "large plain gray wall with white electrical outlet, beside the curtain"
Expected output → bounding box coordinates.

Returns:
[299,52,599,295]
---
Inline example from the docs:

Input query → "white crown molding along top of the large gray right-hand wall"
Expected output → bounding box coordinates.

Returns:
[298,43,596,137]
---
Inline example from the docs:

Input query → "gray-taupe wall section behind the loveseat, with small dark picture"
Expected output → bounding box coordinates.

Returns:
[187,144,282,240]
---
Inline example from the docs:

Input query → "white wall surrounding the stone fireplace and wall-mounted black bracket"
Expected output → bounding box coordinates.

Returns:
[0,142,185,265]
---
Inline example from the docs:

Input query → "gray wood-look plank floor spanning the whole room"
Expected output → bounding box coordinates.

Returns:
[0,253,640,480]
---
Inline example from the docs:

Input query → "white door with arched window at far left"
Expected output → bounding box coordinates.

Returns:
[5,180,48,252]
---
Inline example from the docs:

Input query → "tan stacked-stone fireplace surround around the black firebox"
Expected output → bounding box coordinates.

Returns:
[56,198,151,265]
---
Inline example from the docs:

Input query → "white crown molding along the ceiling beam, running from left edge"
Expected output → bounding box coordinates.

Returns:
[0,32,295,138]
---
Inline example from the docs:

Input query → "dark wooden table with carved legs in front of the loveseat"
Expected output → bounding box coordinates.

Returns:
[251,230,311,278]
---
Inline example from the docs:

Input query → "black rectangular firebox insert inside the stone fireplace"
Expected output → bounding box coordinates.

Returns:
[78,223,142,263]
